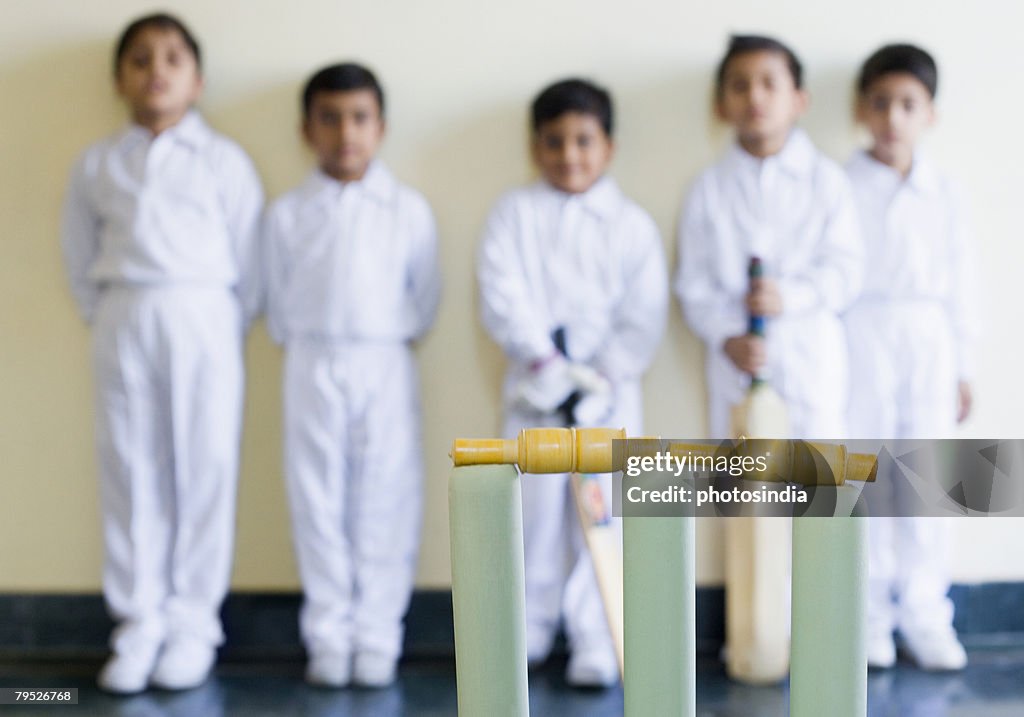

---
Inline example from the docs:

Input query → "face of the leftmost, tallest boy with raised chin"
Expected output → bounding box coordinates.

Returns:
[115,27,203,131]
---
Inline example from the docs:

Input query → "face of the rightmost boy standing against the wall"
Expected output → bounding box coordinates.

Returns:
[857,73,935,162]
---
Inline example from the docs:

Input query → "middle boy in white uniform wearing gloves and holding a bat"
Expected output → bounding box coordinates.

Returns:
[477,80,668,686]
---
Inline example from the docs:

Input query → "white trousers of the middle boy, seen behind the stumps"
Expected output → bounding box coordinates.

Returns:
[505,381,642,659]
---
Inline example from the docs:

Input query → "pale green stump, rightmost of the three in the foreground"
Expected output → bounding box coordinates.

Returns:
[790,486,867,717]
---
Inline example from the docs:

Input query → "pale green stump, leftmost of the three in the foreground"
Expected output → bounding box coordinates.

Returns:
[449,465,529,717]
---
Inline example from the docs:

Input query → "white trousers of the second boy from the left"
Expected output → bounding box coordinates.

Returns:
[285,340,423,657]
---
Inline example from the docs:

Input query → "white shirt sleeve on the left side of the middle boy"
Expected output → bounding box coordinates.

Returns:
[476,195,555,364]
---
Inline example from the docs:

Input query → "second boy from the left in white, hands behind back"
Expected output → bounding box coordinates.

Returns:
[265,64,440,687]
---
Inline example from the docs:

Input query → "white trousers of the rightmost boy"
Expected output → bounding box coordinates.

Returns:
[846,301,957,631]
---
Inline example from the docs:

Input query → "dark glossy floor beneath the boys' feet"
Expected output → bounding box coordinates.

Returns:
[0,646,1024,717]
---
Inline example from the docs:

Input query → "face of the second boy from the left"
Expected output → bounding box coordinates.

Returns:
[302,89,384,181]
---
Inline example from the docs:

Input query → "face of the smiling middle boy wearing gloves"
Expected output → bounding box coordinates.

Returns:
[532,112,614,195]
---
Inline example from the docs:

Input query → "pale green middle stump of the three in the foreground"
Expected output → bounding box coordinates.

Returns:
[623,517,696,717]
